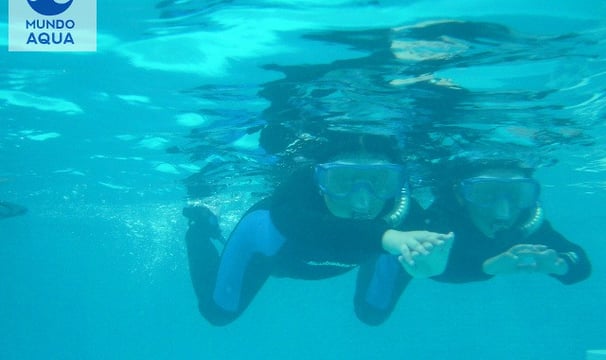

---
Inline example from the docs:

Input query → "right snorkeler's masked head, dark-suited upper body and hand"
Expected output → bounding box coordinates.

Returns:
[427,160,591,284]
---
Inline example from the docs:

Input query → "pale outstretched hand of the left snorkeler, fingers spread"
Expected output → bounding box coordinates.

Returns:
[383,230,454,277]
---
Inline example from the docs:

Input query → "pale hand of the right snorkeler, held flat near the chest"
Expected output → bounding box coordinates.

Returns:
[484,244,568,275]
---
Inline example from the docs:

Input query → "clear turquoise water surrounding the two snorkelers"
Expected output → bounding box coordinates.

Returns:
[0,0,606,359]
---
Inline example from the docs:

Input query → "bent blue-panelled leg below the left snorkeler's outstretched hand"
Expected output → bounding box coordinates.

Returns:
[354,254,411,326]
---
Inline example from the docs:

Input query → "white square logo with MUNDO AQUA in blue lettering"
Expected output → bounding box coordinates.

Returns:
[8,0,97,52]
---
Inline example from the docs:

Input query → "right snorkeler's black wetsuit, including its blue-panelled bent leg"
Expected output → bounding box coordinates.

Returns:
[346,198,591,324]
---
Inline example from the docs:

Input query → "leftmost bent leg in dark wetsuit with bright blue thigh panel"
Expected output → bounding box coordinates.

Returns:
[187,205,284,326]
